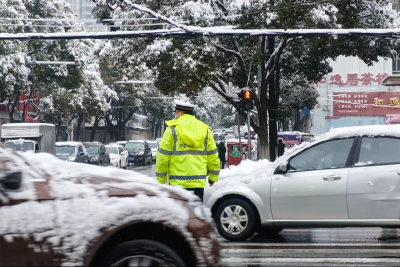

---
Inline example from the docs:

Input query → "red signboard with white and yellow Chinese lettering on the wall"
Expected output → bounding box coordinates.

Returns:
[333,92,400,116]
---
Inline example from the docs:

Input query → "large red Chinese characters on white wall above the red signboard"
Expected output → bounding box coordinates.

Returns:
[317,72,388,86]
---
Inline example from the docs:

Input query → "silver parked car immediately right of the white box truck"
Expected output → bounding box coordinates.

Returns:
[56,141,89,163]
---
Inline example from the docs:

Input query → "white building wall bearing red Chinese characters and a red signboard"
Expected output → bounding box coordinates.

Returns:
[308,56,400,135]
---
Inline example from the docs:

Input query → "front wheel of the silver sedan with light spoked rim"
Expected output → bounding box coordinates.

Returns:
[214,199,256,241]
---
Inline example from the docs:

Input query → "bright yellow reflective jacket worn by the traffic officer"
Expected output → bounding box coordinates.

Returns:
[156,114,220,188]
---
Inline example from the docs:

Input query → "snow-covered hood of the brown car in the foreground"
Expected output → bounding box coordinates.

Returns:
[0,152,197,201]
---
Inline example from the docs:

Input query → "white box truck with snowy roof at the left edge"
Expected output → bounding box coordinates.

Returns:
[1,123,56,155]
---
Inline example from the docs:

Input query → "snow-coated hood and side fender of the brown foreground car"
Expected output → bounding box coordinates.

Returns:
[0,150,203,266]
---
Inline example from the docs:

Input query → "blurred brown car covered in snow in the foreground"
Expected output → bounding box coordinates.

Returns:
[0,147,219,266]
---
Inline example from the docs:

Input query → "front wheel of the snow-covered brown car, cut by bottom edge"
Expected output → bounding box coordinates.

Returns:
[105,240,186,266]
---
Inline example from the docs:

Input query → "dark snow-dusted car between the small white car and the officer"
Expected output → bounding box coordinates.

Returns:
[125,140,153,166]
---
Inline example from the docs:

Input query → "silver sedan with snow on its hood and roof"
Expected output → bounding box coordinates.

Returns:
[204,125,400,243]
